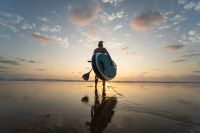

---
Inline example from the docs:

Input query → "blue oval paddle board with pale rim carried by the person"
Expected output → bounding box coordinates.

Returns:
[92,53,117,80]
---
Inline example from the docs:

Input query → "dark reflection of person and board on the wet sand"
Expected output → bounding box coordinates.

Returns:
[86,85,117,133]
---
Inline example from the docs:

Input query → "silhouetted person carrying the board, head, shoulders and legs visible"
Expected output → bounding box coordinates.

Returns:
[93,41,112,85]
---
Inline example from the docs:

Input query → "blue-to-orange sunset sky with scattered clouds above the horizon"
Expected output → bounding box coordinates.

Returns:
[0,0,200,81]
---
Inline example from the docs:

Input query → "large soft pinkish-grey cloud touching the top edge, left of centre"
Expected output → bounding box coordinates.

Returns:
[69,0,101,27]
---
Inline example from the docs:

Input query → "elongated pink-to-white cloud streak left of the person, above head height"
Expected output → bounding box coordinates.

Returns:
[32,32,69,48]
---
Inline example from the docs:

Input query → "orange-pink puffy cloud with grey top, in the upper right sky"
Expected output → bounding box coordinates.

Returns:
[130,11,164,32]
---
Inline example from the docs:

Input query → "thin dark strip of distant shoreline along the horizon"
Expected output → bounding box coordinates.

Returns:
[0,78,200,83]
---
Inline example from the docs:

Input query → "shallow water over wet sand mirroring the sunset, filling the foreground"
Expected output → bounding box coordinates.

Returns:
[0,81,200,133]
